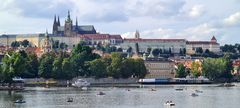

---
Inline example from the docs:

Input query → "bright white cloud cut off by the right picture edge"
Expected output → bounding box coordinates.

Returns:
[224,12,240,26]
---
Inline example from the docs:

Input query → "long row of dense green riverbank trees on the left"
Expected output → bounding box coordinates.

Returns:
[0,44,147,85]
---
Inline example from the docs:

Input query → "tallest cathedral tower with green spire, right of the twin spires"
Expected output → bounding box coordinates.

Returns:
[64,11,72,37]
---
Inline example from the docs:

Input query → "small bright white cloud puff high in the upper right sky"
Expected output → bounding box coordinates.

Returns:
[189,5,204,17]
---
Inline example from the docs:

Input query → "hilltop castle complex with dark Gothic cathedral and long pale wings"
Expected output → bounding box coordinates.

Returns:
[0,12,220,54]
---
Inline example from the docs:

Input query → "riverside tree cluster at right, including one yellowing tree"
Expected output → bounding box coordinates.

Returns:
[176,55,233,81]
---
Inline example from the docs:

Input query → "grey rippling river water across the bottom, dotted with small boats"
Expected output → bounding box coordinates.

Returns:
[0,85,240,108]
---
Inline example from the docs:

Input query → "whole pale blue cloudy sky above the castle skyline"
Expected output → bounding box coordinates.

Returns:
[0,0,240,45]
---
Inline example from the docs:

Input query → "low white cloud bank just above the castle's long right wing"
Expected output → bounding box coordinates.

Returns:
[122,23,219,41]
